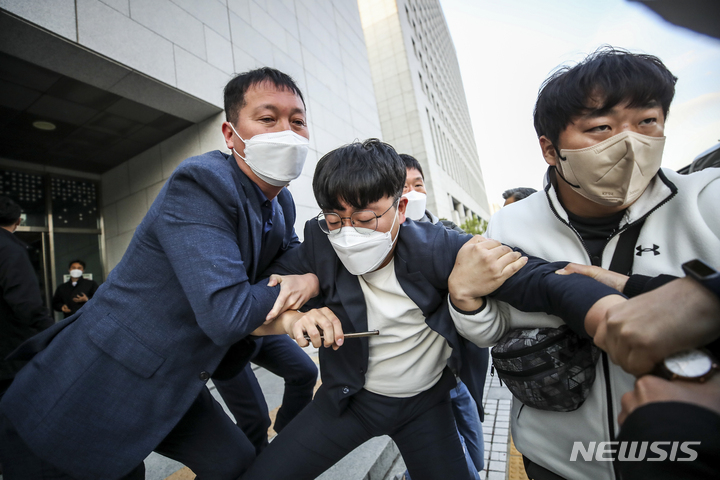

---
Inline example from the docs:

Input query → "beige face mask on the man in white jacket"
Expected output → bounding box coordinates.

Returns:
[557,132,665,207]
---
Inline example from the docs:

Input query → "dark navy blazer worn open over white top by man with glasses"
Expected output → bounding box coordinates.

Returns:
[270,219,618,414]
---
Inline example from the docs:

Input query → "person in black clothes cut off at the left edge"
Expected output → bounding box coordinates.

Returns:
[0,197,53,398]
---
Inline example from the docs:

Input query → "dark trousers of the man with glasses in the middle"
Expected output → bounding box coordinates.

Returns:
[242,369,470,480]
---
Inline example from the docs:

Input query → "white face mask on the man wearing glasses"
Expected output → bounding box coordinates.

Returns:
[328,207,399,275]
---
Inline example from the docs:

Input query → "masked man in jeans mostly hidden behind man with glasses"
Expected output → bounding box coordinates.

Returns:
[400,153,489,480]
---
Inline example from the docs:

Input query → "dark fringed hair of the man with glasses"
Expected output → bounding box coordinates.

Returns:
[313,138,407,210]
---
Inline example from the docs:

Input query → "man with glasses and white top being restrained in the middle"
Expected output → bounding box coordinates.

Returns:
[242,139,617,480]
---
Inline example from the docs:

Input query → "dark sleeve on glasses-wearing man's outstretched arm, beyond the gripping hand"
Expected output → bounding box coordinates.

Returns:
[490,248,622,337]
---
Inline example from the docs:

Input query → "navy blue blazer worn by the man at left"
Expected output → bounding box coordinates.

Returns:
[0,151,298,479]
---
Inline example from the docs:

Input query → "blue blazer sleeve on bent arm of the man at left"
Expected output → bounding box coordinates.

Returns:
[154,164,280,345]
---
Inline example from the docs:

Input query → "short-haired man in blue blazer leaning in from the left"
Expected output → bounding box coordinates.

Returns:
[0,68,317,480]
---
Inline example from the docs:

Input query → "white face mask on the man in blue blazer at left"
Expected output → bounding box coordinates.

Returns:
[228,122,310,187]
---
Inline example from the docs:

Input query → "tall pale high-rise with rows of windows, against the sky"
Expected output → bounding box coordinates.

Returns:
[358,0,490,224]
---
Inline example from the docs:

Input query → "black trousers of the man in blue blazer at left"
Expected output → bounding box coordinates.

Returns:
[0,388,255,480]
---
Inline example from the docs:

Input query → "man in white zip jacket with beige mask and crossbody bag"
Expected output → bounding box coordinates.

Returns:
[450,47,720,480]
